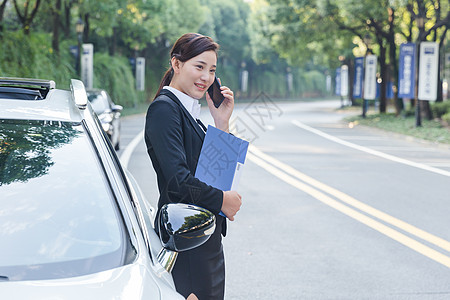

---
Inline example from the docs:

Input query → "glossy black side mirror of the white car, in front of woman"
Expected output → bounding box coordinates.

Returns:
[157,203,216,273]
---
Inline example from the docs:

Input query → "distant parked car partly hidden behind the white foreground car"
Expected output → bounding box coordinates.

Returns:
[86,89,123,150]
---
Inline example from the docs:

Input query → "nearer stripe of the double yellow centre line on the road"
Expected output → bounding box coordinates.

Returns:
[247,153,450,268]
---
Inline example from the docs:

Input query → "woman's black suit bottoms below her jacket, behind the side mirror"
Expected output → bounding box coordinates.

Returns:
[172,216,226,300]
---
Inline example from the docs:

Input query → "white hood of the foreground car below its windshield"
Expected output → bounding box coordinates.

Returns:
[0,264,184,300]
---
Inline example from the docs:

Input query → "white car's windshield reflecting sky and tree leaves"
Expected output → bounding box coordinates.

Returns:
[0,120,130,280]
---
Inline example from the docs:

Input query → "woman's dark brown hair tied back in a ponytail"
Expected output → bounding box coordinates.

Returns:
[155,33,219,98]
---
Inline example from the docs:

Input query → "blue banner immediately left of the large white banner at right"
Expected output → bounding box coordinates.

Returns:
[398,43,416,99]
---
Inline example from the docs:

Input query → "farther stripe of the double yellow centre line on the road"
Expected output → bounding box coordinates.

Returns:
[249,145,450,252]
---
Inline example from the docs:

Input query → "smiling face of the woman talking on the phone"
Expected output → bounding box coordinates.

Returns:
[170,50,217,99]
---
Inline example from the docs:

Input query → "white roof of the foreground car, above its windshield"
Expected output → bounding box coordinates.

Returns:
[0,78,87,122]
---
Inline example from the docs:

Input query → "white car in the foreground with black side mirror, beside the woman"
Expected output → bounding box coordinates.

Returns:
[0,78,215,300]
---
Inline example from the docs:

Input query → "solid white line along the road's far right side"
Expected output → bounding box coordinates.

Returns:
[292,120,450,177]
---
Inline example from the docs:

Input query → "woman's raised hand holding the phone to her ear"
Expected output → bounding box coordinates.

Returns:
[206,79,234,132]
